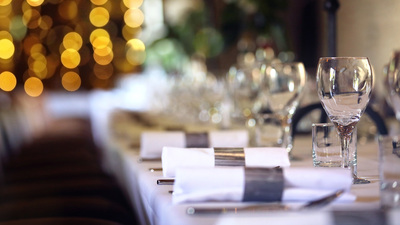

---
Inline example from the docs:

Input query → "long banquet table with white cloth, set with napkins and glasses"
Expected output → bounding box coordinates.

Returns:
[89,101,400,225]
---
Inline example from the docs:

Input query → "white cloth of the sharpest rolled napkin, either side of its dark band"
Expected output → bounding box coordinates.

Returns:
[173,167,356,203]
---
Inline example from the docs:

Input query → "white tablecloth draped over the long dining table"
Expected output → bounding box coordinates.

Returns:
[107,130,384,225]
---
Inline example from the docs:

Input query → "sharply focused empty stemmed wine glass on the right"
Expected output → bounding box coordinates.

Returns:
[317,57,373,184]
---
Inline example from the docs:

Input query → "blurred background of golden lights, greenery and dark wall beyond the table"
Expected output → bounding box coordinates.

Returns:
[0,0,400,139]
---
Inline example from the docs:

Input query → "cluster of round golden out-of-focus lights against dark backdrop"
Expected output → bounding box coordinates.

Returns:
[0,0,147,92]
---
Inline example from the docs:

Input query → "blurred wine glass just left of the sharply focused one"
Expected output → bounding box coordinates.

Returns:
[257,62,307,153]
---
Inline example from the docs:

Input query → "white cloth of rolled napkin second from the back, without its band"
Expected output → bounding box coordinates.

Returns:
[161,147,290,177]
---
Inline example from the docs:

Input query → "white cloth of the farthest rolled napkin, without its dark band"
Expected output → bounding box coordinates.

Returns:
[140,130,249,158]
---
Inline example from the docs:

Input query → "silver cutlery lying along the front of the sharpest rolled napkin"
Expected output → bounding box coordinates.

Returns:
[186,190,344,215]
